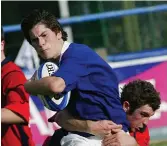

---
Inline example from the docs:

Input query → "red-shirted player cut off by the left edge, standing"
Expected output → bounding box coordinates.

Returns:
[1,27,35,146]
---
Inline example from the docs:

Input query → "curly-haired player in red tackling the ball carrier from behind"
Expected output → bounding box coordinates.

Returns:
[46,80,160,146]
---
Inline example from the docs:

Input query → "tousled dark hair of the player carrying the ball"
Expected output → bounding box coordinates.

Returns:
[21,9,67,44]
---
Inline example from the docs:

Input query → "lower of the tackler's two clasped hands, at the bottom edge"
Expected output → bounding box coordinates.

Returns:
[102,130,138,146]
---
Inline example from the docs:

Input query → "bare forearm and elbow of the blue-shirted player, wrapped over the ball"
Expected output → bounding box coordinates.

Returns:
[24,72,65,95]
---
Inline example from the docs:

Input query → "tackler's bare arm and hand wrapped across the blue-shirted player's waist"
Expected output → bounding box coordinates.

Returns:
[49,109,122,136]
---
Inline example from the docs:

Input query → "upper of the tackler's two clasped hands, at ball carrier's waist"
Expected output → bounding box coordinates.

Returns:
[87,120,122,137]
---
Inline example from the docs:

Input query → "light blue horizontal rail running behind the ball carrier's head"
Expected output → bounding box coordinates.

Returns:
[3,4,167,33]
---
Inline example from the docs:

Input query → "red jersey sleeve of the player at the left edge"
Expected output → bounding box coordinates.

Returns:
[4,72,30,122]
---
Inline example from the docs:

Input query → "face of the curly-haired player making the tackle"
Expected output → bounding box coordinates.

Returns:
[127,105,155,130]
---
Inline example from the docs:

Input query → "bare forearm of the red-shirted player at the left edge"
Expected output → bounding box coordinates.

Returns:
[1,108,27,124]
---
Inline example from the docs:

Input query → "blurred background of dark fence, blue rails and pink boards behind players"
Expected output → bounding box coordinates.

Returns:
[1,1,167,146]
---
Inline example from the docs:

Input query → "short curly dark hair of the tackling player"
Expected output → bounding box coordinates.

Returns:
[121,80,161,114]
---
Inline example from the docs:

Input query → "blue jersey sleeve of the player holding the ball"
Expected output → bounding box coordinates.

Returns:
[53,58,89,93]
